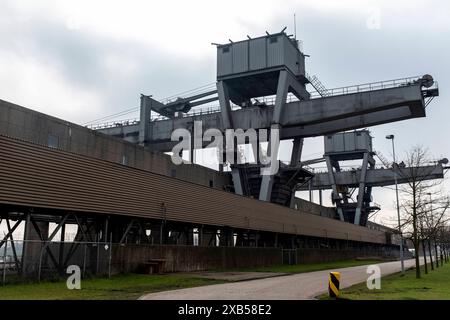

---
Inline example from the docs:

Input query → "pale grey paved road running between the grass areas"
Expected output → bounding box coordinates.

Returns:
[140,259,422,300]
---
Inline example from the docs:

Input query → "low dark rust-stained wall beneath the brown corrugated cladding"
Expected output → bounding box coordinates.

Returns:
[112,245,396,272]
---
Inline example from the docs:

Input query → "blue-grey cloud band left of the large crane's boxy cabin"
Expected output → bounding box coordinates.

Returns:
[0,4,215,120]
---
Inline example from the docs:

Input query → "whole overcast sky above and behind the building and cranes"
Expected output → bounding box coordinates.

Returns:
[0,0,450,230]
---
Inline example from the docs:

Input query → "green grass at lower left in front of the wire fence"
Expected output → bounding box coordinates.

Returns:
[0,274,223,300]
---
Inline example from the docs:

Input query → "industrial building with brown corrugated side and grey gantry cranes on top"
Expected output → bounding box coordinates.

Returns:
[0,30,444,274]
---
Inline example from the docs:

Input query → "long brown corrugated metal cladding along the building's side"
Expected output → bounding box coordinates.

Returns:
[0,136,385,243]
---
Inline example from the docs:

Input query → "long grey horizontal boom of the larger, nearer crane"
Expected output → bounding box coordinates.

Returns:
[99,81,425,152]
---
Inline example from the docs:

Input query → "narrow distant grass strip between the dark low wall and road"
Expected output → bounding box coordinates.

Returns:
[221,259,381,273]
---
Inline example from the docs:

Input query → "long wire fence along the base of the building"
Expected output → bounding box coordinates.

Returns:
[0,239,408,285]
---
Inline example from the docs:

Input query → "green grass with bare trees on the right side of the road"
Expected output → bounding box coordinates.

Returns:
[321,263,450,300]
